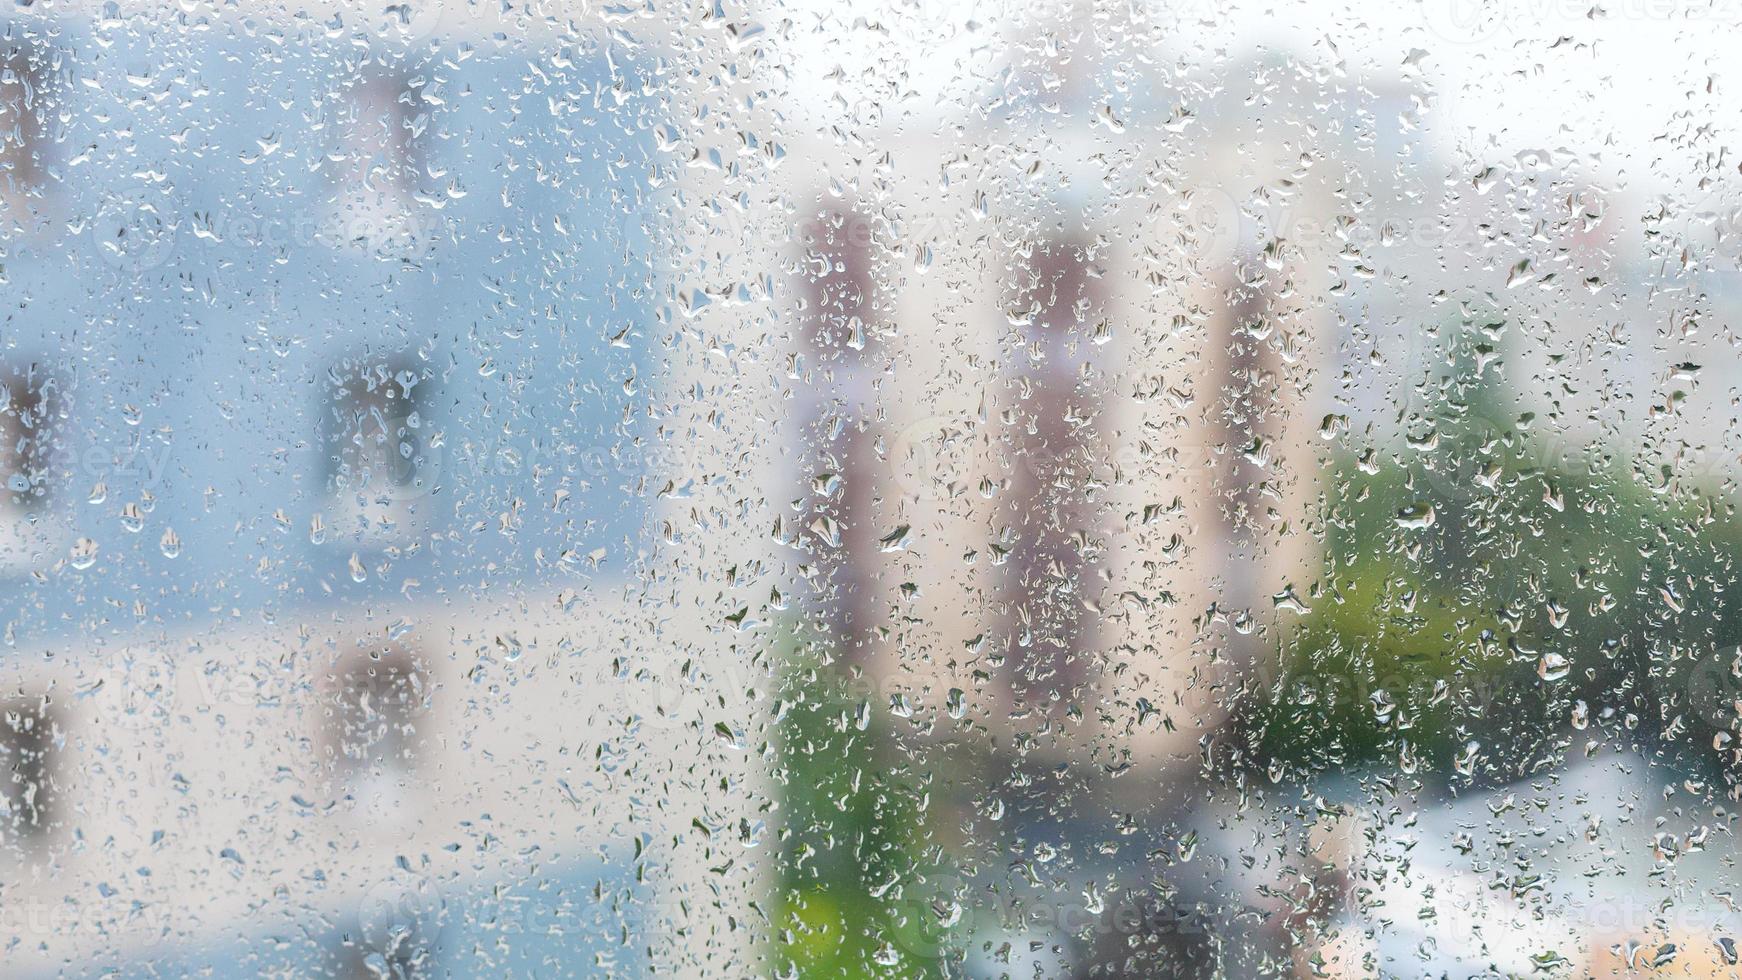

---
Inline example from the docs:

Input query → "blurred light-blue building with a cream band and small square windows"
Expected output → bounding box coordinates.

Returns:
[0,9,769,977]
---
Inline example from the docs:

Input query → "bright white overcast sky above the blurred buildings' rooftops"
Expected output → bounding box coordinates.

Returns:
[756,0,1742,191]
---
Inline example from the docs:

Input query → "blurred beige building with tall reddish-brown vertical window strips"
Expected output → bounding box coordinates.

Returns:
[746,15,1371,974]
